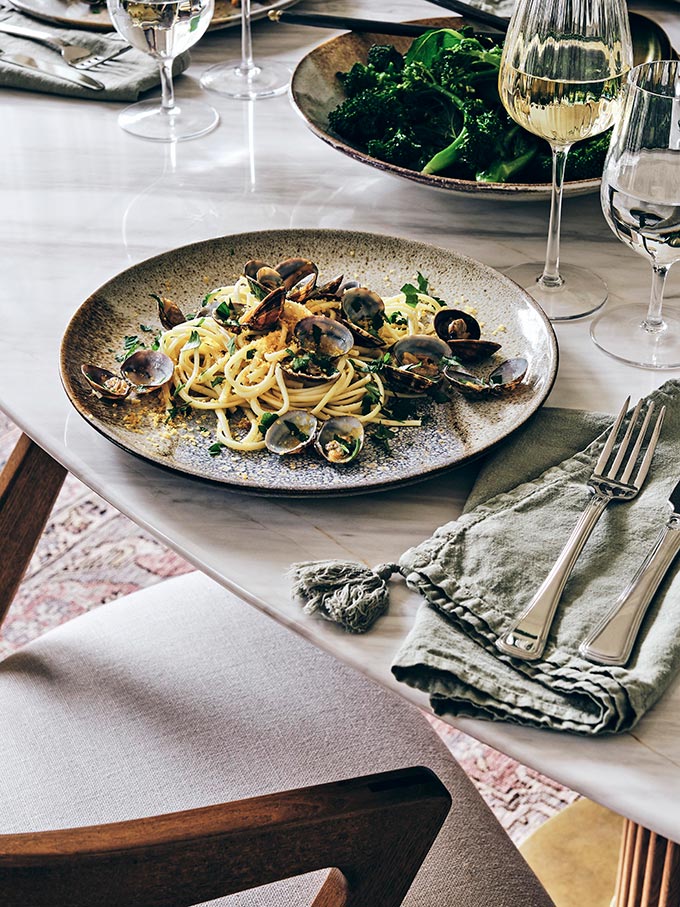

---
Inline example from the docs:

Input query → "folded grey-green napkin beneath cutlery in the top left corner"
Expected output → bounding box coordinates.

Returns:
[0,7,189,101]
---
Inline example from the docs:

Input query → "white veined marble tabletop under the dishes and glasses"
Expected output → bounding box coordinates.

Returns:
[0,0,680,841]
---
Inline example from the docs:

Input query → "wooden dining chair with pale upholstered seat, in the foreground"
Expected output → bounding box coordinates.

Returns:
[0,442,552,907]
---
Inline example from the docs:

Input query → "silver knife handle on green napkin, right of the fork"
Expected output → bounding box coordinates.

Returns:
[579,518,680,665]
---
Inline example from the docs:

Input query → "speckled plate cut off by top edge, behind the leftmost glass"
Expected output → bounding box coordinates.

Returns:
[12,0,298,31]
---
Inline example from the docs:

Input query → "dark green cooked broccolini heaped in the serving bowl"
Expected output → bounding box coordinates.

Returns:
[328,27,609,184]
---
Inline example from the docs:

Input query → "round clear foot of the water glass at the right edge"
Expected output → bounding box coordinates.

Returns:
[590,303,680,369]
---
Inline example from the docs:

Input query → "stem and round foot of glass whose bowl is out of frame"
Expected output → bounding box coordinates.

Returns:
[201,0,290,101]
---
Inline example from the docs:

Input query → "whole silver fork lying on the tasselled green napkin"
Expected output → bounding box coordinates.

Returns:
[496,397,666,661]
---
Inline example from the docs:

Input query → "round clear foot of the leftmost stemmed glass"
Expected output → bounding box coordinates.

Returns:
[118,99,220,142]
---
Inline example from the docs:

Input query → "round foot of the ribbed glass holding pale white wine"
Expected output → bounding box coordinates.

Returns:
[505,262,607,321]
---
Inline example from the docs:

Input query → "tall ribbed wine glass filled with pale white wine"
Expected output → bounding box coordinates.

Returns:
[498,0,633,321]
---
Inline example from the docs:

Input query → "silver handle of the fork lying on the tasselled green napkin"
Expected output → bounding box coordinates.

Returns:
[496,493,611,661]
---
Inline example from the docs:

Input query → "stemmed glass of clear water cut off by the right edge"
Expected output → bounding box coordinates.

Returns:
[590,60,680,368]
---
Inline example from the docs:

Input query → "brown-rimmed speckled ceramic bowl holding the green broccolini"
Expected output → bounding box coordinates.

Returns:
[291,13,673,202]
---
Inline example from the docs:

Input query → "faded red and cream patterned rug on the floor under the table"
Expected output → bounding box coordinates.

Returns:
[0,414,577,843]
